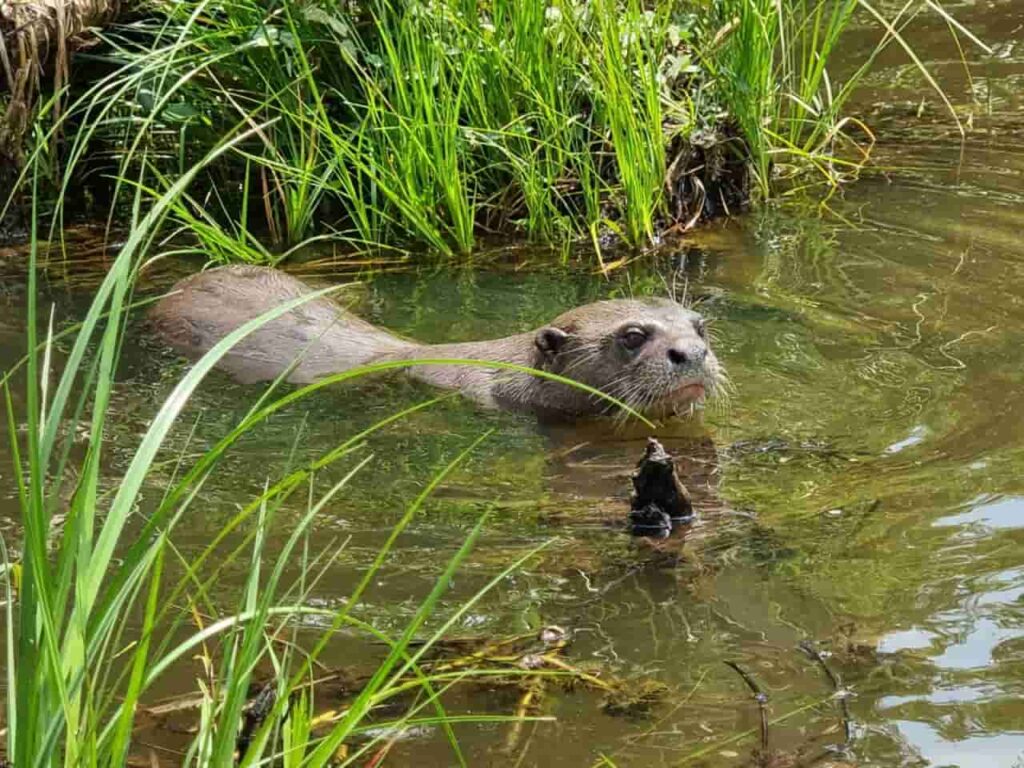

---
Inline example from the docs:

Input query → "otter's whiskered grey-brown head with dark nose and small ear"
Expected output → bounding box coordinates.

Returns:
[535,299,723,413]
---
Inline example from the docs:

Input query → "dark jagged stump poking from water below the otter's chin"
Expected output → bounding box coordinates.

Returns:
[630,437,693,538]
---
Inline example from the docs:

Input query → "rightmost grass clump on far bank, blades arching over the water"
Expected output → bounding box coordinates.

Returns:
[701,0,984,198]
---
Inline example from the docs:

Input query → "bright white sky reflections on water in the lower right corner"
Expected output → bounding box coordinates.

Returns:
[877,487,1024,766]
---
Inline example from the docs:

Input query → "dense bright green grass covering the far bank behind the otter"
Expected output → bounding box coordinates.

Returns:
[4,0,978,263]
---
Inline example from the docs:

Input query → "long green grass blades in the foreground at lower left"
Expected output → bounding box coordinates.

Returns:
[0,143,577,766]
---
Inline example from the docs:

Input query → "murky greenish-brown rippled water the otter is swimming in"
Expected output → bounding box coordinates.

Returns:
[0,3,1024,768]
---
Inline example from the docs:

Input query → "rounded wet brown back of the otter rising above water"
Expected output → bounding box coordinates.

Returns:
[150,266,414,384]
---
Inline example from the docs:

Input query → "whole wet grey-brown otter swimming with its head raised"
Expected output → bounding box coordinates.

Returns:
[150,266,724,419]
